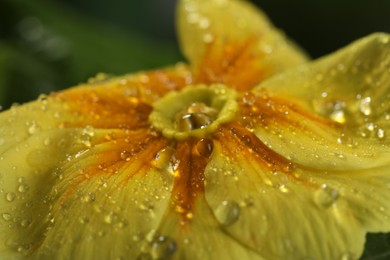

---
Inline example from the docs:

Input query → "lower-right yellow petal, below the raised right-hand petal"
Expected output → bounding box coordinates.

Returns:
[205,123,390,259]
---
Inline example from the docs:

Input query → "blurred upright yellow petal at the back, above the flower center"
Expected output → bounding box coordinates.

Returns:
[178,0,306,89]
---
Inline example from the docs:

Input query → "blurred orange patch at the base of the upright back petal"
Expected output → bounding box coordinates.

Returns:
[195,37,268,90]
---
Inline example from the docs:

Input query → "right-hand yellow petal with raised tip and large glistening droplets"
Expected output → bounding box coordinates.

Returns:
[241,34,390,170]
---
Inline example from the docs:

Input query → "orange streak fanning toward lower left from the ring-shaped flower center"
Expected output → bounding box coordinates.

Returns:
[61,131,168,204]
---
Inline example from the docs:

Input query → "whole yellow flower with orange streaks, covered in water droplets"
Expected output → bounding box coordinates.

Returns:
[0,0,390,259]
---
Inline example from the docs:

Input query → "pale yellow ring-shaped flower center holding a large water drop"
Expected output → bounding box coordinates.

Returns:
[149,84,238,140]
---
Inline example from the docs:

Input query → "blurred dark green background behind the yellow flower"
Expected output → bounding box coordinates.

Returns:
[0,0,390,260]
